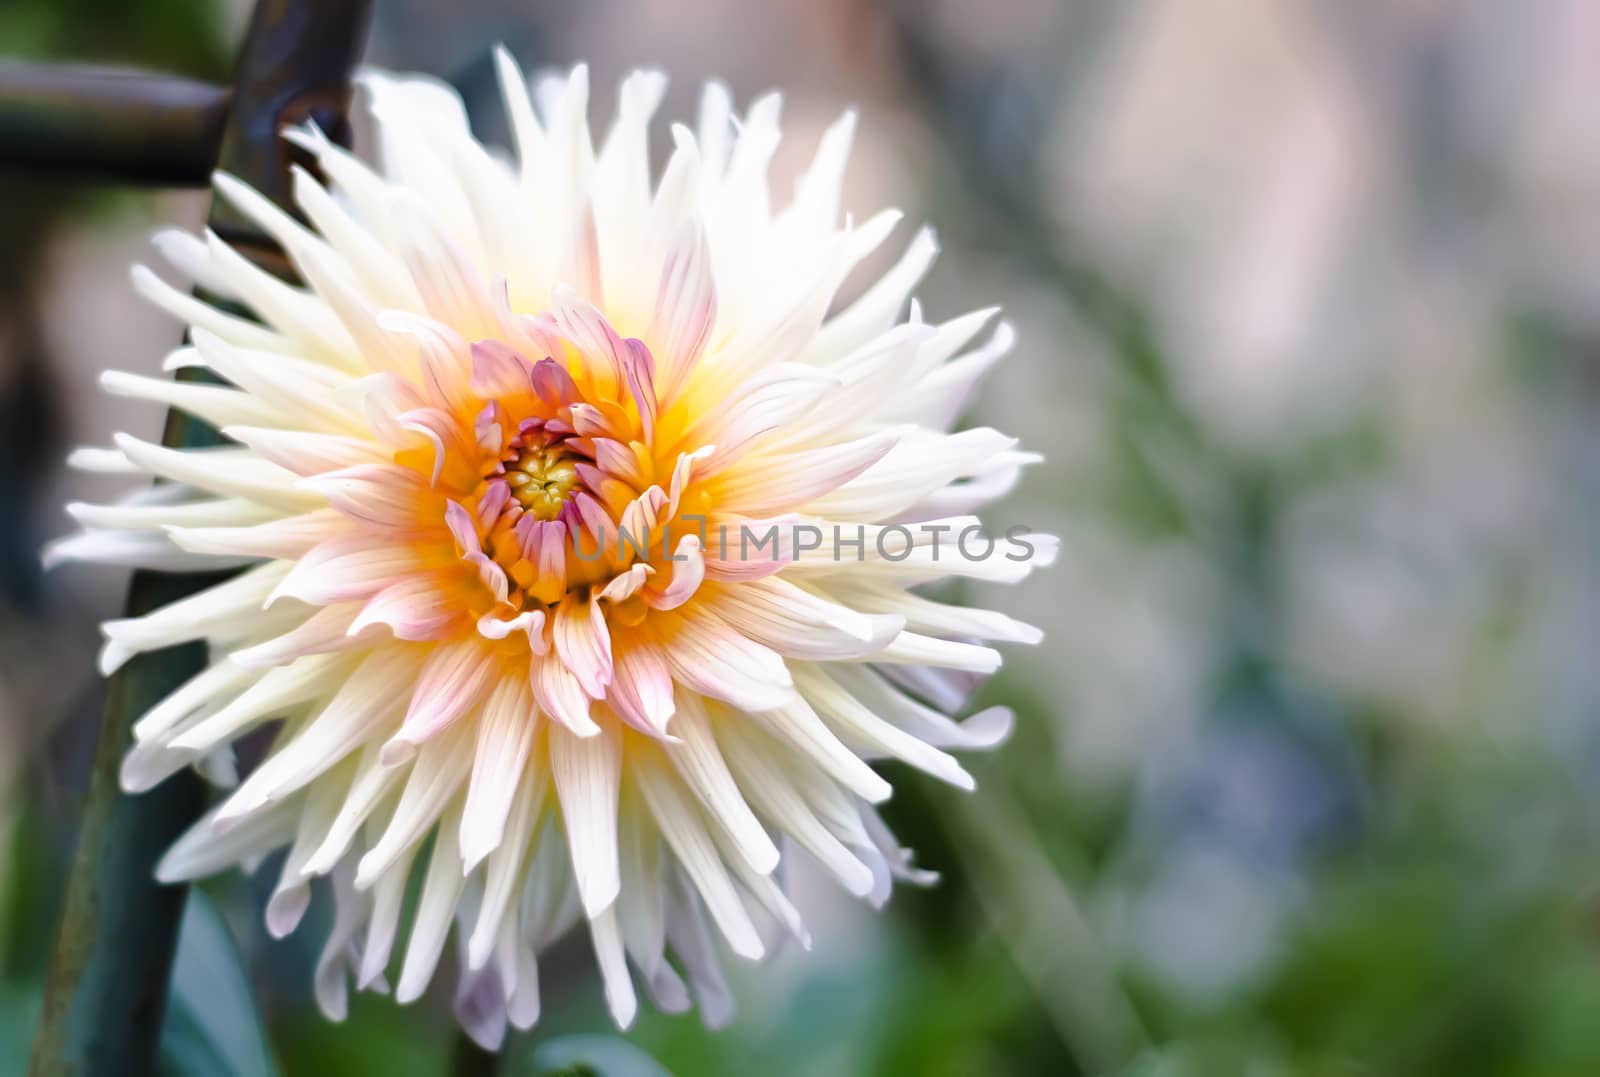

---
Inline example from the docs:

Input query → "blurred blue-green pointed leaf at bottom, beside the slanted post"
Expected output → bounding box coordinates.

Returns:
[158,890,278,1077]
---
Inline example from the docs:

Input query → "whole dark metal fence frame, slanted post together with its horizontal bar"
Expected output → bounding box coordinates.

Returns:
[9,0,370,1077]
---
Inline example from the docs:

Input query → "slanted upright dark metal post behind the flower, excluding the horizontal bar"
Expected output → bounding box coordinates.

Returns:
[30,0,370,1077]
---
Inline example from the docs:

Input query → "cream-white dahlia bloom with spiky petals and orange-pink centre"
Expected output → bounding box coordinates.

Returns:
[48,54,1054,1047]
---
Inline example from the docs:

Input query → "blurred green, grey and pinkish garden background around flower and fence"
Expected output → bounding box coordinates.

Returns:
[0,0,1600,1077]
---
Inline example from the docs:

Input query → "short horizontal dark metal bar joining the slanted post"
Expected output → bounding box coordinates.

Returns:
[0,62,232,187]
